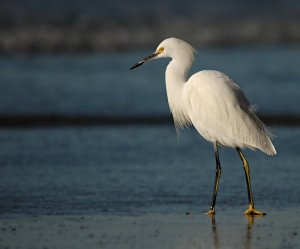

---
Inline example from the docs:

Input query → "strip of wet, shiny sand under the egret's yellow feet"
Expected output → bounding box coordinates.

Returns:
[0,208,300,249]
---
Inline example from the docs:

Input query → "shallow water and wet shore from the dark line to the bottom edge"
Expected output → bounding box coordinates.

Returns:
[0,125,300,249]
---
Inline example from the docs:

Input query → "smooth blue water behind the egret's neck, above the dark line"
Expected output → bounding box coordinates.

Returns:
[0,47,300,116]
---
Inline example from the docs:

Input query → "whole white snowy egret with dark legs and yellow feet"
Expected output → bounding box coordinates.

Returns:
[130,38,276,215]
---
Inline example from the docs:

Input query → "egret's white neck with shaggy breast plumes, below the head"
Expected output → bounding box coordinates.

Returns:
[166,59,191,128]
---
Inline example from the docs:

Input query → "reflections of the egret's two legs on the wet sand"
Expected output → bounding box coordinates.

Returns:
[209,215,261,249]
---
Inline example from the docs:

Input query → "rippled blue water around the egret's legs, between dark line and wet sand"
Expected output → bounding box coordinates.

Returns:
[0,125,300,216]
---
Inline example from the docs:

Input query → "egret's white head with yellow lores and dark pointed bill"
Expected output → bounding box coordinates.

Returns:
[130,37,195,70]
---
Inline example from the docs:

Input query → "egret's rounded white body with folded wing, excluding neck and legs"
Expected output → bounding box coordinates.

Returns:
[184,70,275,154]
